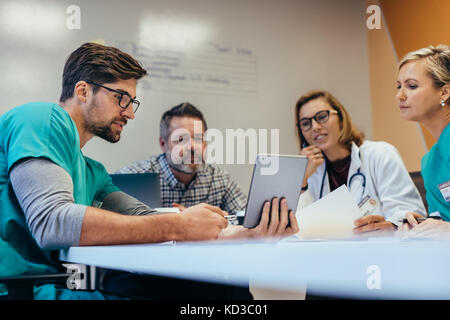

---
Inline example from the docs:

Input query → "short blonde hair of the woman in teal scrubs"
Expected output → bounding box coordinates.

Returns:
[398,44,450,88]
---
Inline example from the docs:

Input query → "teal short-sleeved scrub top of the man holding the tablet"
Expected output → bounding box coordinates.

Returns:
[0,103,119,276]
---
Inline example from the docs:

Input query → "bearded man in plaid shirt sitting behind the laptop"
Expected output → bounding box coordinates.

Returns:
[117,103,247,214]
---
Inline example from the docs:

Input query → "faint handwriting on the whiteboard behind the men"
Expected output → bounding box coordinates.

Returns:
[108,41,257,98]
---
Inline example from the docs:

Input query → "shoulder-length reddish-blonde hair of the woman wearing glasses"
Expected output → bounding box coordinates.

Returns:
[295,90,364,149]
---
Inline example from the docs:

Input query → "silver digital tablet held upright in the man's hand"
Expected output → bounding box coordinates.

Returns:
[244,154,308,228]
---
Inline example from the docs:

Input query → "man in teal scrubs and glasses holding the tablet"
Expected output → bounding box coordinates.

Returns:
[0,43,298,299]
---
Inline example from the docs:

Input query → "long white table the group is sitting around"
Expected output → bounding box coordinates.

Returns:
[60,239,450,299]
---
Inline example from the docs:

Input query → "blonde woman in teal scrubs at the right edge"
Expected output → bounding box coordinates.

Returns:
[396,45,450,239]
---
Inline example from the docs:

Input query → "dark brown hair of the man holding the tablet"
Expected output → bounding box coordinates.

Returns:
[59,42,147,102]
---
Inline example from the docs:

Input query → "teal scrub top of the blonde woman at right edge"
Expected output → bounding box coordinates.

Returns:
[422,124,450,221]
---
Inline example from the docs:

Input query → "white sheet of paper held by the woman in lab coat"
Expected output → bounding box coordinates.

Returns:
[297,185,362,239]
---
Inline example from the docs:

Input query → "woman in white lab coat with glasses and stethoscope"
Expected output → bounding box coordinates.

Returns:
[295,90,426,236]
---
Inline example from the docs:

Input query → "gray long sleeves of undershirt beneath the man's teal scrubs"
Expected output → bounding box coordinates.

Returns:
[10,158,155,249]
